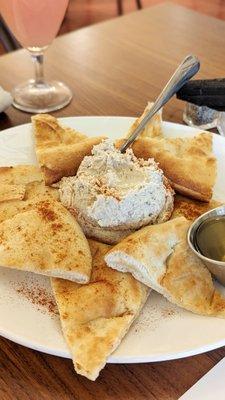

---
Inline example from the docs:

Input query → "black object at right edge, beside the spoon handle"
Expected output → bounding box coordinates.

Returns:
[177,78,225,111]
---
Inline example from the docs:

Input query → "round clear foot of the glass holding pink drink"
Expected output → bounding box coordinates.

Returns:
[12,79,73,113]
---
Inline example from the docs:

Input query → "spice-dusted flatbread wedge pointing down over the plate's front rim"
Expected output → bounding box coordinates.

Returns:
[52,241,149,380]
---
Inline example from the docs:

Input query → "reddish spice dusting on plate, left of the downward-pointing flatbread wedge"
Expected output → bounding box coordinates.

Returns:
[14,282,58,315]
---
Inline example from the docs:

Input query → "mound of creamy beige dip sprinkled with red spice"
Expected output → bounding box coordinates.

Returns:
[59,140,173,230]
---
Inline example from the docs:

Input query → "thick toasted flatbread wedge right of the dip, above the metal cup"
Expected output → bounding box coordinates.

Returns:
[116,132,216,201]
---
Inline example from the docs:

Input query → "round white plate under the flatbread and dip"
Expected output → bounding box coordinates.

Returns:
[0,117,225,363]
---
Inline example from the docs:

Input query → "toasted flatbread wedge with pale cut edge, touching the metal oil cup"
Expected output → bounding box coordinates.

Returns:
[105,217,225,317]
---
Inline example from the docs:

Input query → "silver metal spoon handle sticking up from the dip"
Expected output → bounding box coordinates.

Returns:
[120,55,200,153]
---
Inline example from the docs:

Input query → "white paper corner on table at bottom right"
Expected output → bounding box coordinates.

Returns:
[179,358,225,400]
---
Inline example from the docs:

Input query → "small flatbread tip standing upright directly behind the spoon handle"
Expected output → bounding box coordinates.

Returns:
[126,102,163,138]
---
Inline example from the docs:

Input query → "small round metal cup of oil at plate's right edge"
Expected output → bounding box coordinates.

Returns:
[187,206,225,286]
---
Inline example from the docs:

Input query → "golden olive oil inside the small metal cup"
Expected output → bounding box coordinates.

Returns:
[194,216,225,262]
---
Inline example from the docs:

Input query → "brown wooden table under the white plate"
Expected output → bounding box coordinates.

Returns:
[0,3,225,400]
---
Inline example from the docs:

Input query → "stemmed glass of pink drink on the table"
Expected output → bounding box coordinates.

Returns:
[0,0,72,113]
